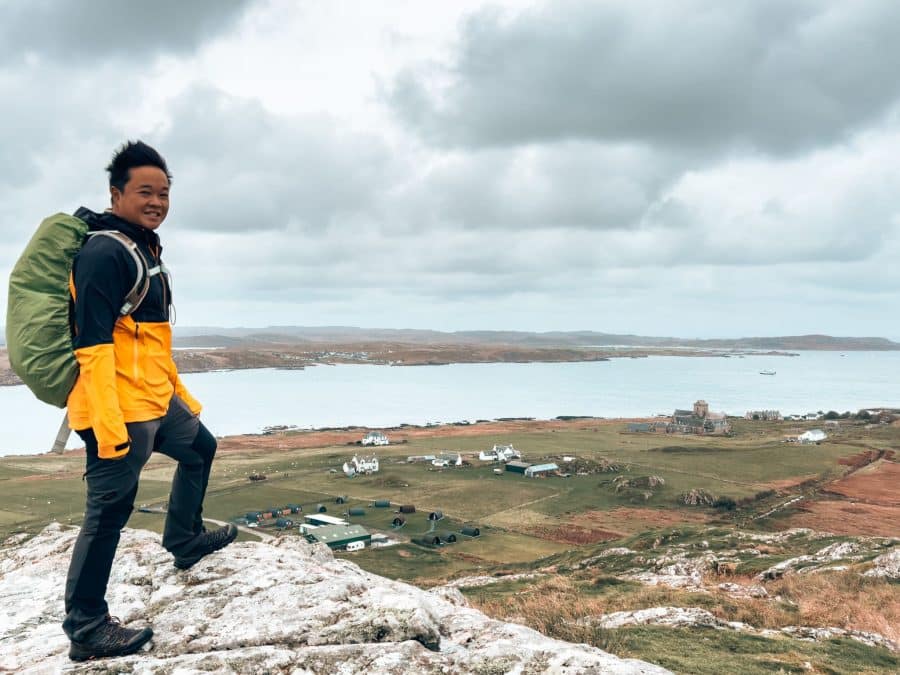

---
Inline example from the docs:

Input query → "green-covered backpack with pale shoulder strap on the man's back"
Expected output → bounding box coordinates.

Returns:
[6,213,150,408]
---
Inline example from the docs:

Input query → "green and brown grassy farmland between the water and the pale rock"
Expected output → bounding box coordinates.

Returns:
[0,419,900,672]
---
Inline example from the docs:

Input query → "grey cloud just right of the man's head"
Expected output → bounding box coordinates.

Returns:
[158,86,400,235]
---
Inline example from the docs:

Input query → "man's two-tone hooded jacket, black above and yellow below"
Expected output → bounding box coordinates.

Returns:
[68,208,201,459]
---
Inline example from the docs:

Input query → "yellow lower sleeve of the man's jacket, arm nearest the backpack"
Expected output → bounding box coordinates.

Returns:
[75,344,129,459]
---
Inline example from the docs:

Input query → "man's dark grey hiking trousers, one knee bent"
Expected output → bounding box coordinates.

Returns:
[63,396,216,641]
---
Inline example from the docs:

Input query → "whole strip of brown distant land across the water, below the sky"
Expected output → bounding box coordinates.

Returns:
[0,326,900,386]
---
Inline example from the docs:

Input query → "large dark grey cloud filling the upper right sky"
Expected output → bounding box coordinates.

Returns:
[389,0,900,153]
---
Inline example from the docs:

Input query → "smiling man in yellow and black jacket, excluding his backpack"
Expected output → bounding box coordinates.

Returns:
[63,141,237,661]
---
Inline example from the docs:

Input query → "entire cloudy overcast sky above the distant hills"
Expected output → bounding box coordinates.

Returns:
[0,0,900,339]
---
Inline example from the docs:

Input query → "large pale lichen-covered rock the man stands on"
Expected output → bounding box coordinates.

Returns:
[0,525,668,674]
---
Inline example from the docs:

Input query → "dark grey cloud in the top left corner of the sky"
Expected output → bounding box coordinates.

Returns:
[0,0,250,65]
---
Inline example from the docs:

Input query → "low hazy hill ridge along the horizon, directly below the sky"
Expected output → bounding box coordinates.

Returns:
[175,326,900,351]
